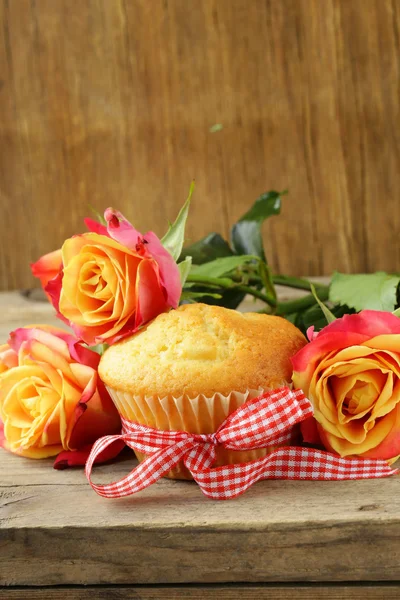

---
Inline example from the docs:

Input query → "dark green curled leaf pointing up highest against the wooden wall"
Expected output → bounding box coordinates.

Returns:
[231,191,286,262]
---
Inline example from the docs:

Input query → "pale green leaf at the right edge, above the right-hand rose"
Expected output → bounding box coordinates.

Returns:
[329,271,400,311]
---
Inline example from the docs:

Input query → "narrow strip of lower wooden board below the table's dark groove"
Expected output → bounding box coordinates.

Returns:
[0,585,400,600]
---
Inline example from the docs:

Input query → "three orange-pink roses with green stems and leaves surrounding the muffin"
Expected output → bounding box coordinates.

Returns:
[0,186,400,496]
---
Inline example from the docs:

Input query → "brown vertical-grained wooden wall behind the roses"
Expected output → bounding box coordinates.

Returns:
[0,0,400,289]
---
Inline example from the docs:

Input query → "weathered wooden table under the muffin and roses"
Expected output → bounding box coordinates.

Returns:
[0,293,400,600]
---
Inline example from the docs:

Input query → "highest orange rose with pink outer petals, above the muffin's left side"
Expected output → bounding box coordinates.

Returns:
[33,208,182,345]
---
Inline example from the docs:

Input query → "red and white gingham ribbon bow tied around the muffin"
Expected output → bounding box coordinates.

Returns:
[86,388,397,500]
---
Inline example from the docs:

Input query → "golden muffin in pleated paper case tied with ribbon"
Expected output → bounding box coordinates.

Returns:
[99,304,306,479]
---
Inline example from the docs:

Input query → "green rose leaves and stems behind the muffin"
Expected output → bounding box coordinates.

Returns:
[180,186,400,332]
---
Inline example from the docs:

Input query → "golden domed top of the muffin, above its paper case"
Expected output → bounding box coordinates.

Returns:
[99,304,306,397]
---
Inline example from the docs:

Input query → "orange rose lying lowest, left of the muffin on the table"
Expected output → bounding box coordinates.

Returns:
[0,326,120,466]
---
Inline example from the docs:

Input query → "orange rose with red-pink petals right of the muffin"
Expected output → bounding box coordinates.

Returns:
[292,310,400,459]
